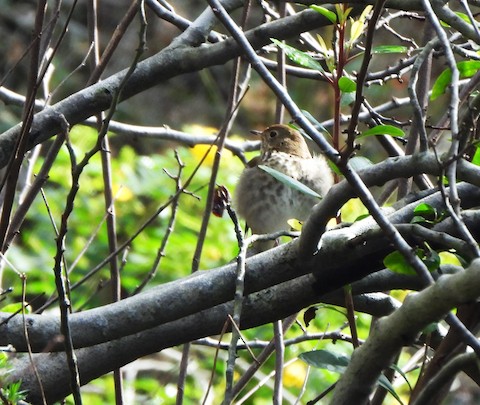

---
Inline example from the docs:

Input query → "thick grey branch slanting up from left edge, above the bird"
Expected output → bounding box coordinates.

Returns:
[0,10,334,167]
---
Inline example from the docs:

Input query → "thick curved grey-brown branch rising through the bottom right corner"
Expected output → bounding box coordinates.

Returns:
[332,260,480,404]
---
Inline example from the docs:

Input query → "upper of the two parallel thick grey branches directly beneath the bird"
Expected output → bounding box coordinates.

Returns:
[0,157,480,350]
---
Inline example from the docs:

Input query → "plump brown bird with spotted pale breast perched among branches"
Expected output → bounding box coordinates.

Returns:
[235,125,333,251]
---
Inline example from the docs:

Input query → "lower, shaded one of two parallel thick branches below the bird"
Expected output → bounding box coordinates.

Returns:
[3,268,456,403]
